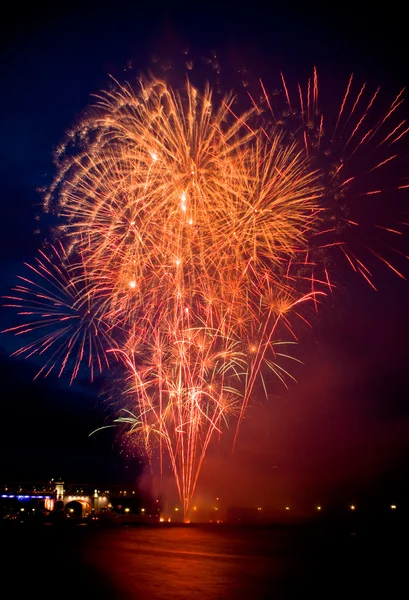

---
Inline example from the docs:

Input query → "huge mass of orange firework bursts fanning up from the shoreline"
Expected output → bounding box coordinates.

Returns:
[3,73,406,518]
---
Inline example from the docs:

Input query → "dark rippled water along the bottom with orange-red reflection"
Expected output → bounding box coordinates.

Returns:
[0,524,408,600]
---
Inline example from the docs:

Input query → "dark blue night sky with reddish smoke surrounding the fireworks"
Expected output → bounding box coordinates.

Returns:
[0,1,409,505]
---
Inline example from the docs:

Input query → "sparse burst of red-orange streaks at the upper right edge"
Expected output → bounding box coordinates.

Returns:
[250,69,409,289]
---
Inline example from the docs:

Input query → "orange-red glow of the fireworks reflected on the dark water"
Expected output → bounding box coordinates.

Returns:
[81,528,287,599]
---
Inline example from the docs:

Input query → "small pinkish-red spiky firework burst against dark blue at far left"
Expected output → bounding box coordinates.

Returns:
[3,243,115,383]
